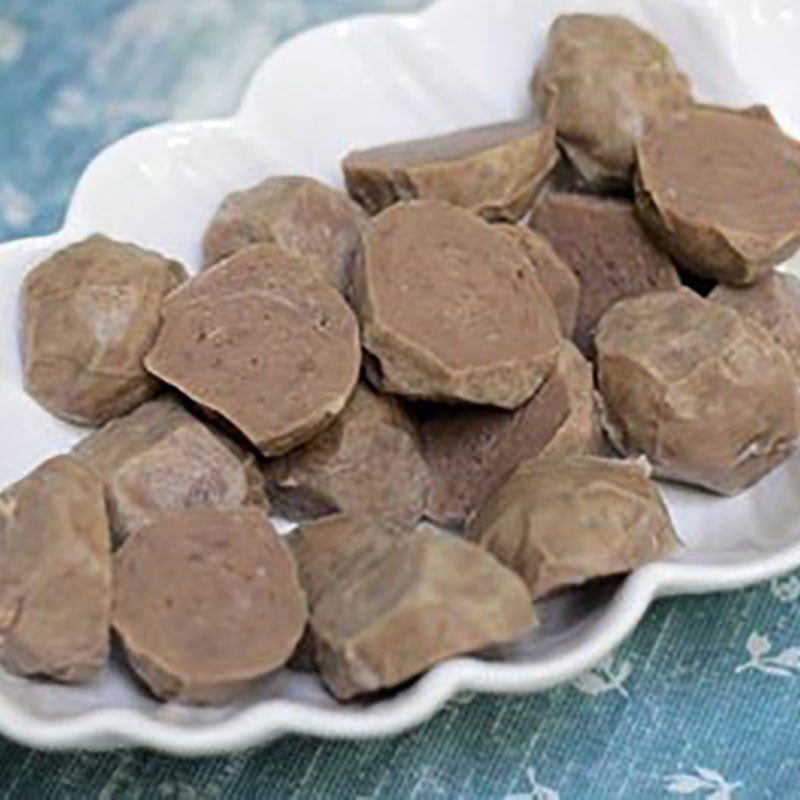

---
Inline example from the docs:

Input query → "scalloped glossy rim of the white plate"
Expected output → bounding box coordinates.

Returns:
[0,0,800,756]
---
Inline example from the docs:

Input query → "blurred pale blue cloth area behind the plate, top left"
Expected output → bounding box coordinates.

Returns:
[0,0,427,240]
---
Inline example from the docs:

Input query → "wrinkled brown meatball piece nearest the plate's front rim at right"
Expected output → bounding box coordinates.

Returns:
[470,456,677,600]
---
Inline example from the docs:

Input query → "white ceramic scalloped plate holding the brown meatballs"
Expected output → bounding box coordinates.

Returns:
[0,0,800,754]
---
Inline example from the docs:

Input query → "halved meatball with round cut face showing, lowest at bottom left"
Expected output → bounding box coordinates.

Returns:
[113,508,307,704]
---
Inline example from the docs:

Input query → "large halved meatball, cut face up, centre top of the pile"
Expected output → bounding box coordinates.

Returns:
[354,200,561,408]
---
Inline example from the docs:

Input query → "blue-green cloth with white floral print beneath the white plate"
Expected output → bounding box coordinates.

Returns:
[0,0,800,800]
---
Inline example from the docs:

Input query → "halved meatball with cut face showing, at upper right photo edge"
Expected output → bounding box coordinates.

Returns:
[636,106,800,285]
